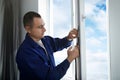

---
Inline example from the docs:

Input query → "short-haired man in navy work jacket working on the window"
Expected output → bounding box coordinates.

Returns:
[16,11,79,80]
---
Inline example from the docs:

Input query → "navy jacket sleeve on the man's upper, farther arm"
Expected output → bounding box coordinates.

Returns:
[45,36,72,52]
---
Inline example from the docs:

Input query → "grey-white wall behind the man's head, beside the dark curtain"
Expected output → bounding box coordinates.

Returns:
[20,0,38,40]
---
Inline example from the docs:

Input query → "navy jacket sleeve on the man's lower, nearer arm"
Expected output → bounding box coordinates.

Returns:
[16,50,70,80]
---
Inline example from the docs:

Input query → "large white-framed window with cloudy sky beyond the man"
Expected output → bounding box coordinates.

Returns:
[39,0,109,80]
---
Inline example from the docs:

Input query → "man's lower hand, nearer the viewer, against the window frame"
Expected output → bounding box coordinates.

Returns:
[67,46,79,63]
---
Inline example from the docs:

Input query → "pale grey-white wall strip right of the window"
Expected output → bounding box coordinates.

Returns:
[109,0,120,80]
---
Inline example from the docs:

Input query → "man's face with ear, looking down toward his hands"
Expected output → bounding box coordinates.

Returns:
[27,17,46,41]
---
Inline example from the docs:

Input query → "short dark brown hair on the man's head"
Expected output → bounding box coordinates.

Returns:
[23,11,41,27]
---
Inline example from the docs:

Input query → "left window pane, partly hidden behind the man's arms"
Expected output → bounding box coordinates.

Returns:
[53,0,74,80]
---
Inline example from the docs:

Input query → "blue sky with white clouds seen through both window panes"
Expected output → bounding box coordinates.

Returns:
[53,0,108,80]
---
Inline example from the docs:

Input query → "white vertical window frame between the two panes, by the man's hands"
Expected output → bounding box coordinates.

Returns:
[73,0,86,80]
